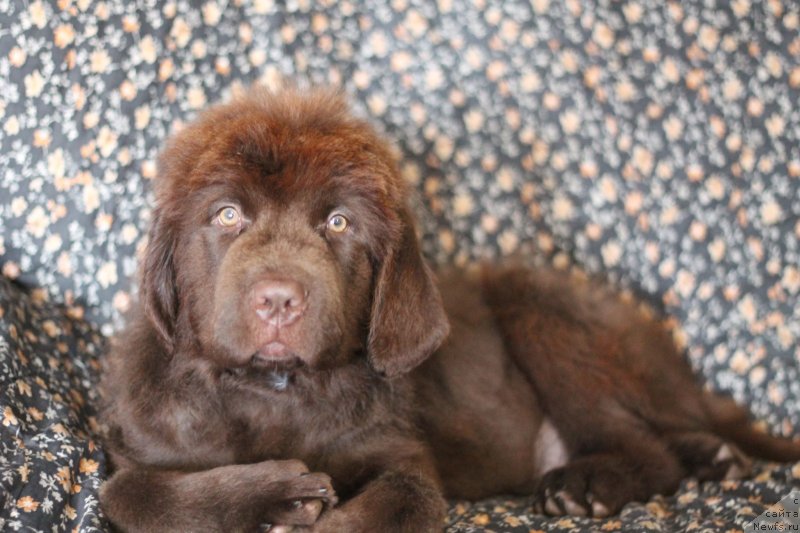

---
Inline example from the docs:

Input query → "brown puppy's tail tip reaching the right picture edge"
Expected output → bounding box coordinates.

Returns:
[704,394,800,463]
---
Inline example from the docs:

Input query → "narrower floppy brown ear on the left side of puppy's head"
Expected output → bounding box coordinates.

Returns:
[139,209,178,352]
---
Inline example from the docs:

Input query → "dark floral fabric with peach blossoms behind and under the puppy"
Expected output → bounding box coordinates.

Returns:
[0,0,800,531]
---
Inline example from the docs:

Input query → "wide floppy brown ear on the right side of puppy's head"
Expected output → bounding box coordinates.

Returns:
[367,210,450,378]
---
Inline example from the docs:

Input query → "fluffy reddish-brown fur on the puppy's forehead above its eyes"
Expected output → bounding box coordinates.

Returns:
[177,109,397,204]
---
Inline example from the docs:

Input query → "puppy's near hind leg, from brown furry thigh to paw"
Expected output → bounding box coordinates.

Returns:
[485,269,693,516]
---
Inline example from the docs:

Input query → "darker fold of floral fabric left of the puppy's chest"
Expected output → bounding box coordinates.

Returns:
[0,278,105,531]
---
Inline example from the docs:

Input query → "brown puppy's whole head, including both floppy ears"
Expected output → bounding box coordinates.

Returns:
[142,89,447,376]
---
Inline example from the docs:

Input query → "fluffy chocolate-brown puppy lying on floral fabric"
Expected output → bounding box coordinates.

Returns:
[101,85,800,532]
